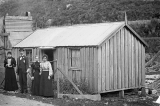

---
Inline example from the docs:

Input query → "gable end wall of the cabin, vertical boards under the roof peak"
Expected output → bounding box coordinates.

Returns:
[98,28,145,92]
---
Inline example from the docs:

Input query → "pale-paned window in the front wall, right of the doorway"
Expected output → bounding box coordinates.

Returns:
[70,49,80,68]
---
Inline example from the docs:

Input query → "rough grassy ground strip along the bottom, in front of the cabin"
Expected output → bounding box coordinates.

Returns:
[0,90,159,106]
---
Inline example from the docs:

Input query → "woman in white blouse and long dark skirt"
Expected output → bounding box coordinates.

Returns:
[40,55,53,97]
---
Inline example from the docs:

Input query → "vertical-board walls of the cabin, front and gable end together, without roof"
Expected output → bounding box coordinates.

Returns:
[13,27,145,93]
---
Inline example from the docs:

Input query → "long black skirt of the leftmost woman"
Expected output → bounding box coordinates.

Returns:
[4,68,18,91]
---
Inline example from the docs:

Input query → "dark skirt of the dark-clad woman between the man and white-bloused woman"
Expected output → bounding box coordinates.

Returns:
[31,71,40,96]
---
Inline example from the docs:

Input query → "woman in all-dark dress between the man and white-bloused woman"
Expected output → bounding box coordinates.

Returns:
[31,56,40,96]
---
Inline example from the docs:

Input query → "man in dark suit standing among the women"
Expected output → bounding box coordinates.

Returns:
[17,48,29,93]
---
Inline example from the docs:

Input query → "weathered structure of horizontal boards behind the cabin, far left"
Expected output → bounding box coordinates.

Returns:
[0,15,33,83]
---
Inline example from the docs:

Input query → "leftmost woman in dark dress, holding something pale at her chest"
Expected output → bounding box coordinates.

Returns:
[4,52,18,92]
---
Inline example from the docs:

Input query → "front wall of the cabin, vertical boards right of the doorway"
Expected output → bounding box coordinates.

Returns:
[54,47,98,92]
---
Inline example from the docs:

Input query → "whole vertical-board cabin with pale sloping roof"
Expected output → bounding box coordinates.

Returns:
[14,22,147,93]
